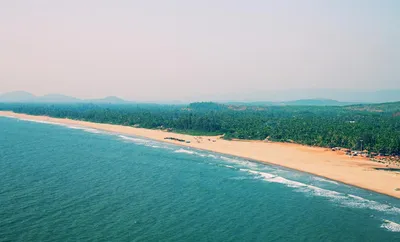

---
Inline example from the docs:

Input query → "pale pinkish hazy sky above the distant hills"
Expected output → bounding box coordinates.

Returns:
[0,0,400,101]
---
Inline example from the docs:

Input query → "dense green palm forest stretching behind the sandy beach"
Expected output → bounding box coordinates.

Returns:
[0,102,400,154]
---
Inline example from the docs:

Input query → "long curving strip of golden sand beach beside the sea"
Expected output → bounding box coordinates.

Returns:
[0,111,400,198]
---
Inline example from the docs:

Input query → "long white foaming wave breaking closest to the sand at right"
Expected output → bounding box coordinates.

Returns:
[240,169,400,214]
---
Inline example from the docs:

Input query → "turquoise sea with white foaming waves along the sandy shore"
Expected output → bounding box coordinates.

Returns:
[0,117,400,241]
